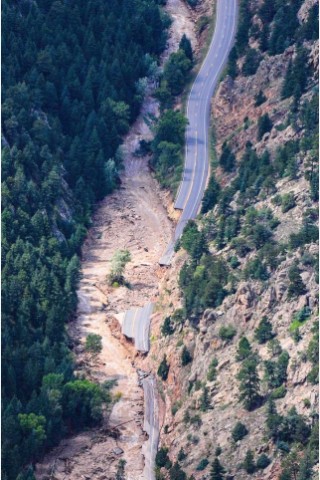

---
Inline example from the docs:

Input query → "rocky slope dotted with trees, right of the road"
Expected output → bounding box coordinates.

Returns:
[151,1,318,480]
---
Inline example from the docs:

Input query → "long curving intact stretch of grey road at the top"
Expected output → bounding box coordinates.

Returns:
[159,0,237,265]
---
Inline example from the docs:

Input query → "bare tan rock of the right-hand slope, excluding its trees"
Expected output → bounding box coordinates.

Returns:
[150,1,318,480]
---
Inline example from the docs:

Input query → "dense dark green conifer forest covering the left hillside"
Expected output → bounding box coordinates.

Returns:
[2,0,169,480]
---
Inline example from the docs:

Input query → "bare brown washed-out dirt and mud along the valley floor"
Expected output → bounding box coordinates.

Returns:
[36,0,204,480]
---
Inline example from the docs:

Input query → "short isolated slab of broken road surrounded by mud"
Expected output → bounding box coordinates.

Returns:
[122,303,153,353]
